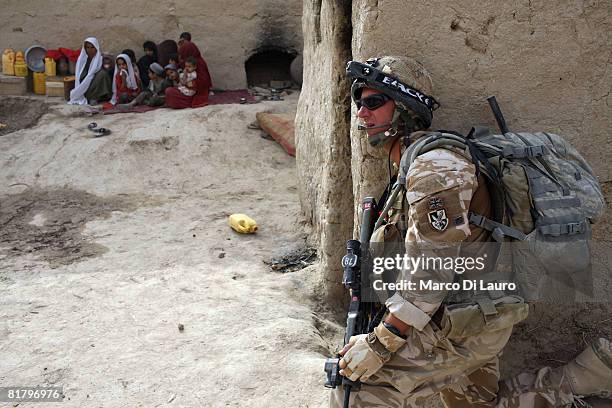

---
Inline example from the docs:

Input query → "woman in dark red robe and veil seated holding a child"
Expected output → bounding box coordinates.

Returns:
[166,36,212,109]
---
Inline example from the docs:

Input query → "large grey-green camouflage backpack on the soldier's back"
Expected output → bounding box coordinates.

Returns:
[400,128,605,300]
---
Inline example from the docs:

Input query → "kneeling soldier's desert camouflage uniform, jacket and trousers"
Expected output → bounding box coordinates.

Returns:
[330,145,572,408]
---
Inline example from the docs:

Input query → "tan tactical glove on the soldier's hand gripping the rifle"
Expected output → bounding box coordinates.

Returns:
[340,323,406,381]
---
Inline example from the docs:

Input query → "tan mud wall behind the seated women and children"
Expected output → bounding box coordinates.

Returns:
[0,0,302,89]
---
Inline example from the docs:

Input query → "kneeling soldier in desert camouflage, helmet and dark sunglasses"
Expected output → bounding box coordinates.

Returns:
[330,56,612,408]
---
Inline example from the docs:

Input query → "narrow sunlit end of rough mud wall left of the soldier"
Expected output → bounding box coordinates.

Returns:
[296,0,353,299]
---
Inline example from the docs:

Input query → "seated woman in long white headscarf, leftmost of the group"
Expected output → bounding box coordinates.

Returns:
[68,37,112,105]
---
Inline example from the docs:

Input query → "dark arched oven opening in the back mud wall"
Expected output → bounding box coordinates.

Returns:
[244,49,297,86]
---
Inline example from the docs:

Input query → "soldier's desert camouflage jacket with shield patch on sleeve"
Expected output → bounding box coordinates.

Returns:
[371,140,490,330]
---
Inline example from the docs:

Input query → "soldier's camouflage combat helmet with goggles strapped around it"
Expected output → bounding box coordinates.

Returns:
[346,56,440,146]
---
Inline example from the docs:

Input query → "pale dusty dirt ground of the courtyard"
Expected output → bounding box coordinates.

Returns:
[0,95,327,407]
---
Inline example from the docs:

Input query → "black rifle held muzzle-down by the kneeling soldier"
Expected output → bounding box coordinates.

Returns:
[325,197,382,408]
